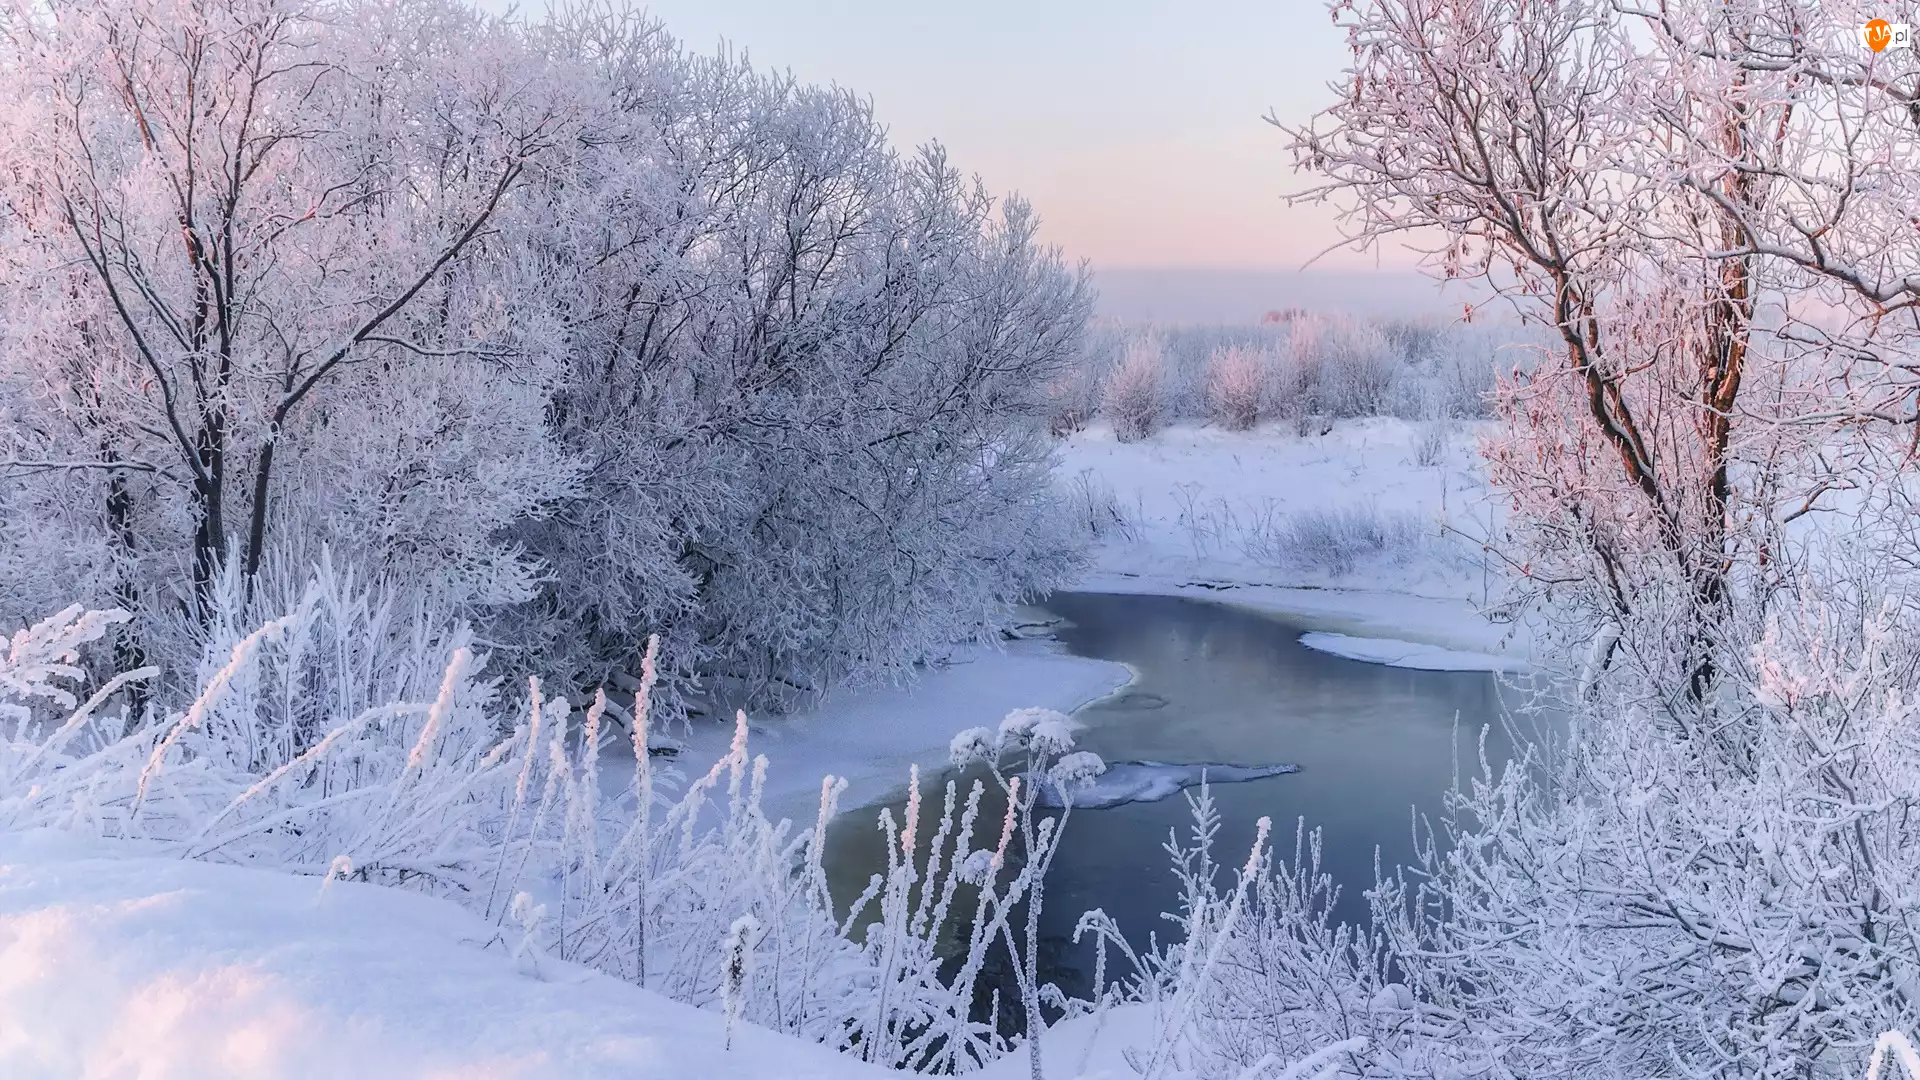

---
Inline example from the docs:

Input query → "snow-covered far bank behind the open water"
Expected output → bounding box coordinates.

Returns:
[1060,417,1530,671]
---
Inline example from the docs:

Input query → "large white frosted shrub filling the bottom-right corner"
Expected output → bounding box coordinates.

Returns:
[1375,580,1920,1078]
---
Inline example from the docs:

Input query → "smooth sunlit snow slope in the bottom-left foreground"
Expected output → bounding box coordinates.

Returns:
[0,832,887,1080]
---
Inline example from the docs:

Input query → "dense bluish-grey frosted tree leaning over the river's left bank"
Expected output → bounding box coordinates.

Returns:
[510,10,1089,701]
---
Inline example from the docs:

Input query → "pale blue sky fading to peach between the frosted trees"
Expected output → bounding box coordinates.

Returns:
[493,0,1405,269]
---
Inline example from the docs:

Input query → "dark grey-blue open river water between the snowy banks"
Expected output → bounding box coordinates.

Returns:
[829,594,1507,992]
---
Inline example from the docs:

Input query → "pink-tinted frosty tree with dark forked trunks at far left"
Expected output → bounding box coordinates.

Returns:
[0,0,580,664]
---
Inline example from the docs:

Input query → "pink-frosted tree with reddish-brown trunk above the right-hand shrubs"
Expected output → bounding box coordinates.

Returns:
[1290,0,1920,700]
